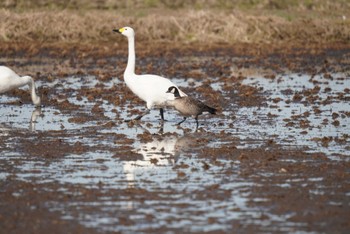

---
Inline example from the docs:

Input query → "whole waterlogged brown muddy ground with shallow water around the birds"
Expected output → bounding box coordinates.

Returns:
[0,44,350,233]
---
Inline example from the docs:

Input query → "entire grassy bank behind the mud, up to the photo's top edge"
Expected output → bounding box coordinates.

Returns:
[0,0,350,44]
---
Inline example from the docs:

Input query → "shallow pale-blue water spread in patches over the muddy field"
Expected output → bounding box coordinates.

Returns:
[0,71,350,232]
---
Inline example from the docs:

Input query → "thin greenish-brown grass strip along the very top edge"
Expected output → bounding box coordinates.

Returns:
[0,0,350,12]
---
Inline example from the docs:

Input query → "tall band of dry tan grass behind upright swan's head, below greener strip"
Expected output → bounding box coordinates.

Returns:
[0,3,350,44]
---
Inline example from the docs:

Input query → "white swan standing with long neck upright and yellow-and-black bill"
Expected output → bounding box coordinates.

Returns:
[113,27,187,121]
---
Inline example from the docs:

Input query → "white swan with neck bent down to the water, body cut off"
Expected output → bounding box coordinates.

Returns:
[0,66,41,106]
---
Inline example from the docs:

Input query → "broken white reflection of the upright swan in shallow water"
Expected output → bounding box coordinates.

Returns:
[123,134,194,187]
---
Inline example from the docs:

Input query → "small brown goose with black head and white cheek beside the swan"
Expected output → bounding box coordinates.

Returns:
[167,86,217,129]
